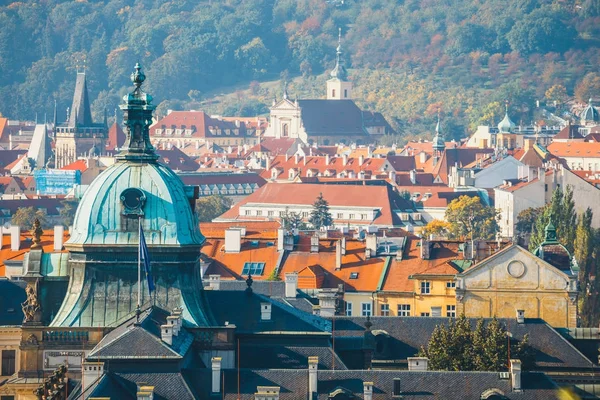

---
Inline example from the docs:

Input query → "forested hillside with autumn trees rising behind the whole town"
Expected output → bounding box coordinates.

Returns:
[0,0,600,136]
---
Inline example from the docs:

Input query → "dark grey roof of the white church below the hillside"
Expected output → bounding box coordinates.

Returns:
[298,99,368,137]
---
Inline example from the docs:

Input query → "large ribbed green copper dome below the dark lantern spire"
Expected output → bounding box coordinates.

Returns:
[65,161,204,248]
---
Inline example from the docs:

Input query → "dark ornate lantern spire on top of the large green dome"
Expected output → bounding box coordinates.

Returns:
[116,63,158,162]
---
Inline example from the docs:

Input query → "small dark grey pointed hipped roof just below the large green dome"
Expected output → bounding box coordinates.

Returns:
[87,308,194,360]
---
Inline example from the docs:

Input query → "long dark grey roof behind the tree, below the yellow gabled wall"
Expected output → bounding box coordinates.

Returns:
[335,317,593,369]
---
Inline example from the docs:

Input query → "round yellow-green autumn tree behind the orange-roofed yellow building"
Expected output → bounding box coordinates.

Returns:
[446,196,498,239]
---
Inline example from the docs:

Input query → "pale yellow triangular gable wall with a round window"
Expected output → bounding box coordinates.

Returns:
[457,246,577,327]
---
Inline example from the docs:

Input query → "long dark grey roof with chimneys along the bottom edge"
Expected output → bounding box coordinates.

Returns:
[186,369,557,400]
